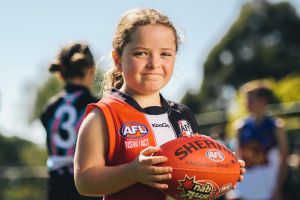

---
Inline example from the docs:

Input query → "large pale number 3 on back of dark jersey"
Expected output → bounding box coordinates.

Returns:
[53,104,77,149]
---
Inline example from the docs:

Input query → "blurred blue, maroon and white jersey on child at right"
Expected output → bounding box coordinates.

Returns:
[236,116,280,199]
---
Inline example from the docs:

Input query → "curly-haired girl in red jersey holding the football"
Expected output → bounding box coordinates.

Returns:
[74,9,245,200]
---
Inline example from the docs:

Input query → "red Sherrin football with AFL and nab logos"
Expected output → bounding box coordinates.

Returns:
[156,135,240,200]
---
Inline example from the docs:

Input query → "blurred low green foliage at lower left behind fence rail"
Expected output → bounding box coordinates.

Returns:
[0,133,47,200]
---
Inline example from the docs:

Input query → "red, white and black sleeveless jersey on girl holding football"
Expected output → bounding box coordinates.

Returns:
[87,89,198,200]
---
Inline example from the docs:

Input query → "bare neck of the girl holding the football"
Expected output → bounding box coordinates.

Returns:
[120,87,162,108]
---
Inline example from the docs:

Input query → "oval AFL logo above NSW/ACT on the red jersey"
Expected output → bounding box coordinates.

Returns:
[119,122,148,139]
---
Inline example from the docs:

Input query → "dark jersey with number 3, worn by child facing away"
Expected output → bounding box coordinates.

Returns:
[41,84,97,170]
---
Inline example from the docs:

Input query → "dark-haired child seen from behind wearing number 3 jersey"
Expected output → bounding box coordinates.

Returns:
[41,42,99,200]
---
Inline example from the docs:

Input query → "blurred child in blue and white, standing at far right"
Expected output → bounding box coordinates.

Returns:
[230,80,288,200]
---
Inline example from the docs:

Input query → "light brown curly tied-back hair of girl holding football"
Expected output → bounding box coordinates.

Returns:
[104,8,180,91]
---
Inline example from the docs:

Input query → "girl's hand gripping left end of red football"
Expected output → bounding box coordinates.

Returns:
[132,146,172,190]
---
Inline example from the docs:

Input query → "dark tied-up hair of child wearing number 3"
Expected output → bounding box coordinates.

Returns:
[49,42,95,80]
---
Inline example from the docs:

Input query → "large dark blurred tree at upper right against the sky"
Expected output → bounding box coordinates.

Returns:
[183,0,300,113]
